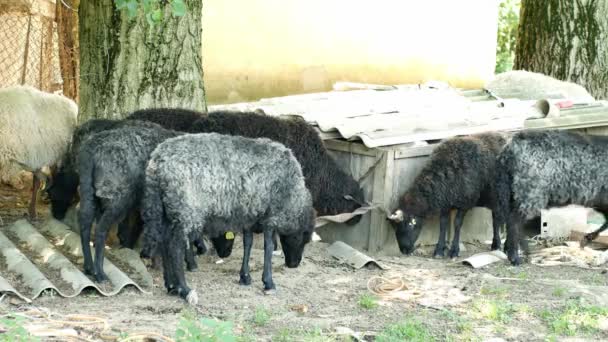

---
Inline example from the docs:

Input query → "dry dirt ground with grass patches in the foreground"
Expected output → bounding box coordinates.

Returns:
[0,186,608,341]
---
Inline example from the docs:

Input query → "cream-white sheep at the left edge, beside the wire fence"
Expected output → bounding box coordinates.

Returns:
[0,86,78,218]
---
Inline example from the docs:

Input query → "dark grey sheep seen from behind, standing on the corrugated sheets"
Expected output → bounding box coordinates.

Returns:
[77,120,179,282]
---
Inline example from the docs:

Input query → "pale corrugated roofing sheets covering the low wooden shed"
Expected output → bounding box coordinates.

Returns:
[209,84,608,148]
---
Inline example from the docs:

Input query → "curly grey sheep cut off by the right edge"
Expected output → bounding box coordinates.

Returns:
[496,130,608,265]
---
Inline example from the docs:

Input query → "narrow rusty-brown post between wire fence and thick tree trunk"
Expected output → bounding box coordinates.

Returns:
[55,0,80,102]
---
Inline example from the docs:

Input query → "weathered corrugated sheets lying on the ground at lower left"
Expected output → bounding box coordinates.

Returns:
[0,219,152,302]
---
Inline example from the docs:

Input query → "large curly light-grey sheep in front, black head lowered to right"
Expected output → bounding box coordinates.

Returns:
[141,133,315,304]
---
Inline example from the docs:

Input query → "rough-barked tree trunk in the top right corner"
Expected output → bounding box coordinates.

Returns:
[515,0,608,99]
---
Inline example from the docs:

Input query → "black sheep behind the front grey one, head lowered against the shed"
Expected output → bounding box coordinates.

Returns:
[188,111,365,256]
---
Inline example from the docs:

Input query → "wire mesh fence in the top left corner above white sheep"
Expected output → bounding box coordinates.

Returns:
[0,8,63,92]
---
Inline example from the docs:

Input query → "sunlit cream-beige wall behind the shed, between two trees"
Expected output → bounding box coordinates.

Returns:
[203,0,498,104]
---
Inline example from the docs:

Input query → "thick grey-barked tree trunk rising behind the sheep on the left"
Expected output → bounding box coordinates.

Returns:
[79,0,206,122]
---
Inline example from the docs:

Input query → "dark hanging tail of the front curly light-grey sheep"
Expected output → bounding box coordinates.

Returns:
[140,170,165,258]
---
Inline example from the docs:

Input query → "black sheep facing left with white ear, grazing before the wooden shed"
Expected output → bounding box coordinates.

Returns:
[389,133,506,258]
